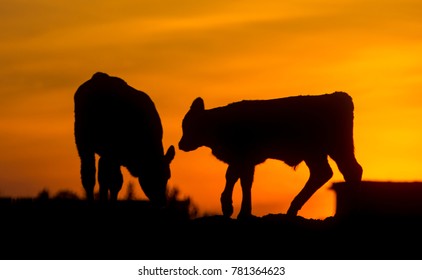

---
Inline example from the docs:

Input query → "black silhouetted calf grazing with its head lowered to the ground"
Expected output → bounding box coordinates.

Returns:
[74,72,175,206]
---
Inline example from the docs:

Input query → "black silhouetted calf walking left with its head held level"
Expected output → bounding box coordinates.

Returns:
[179,92,362,218]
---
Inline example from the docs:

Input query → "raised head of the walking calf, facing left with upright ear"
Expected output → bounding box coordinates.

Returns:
[179,97,205,152]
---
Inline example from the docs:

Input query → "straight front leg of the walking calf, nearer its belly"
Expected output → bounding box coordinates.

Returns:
[237,165,255,219]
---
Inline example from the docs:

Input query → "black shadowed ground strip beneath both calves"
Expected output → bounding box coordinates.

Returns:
[0,200,422,260]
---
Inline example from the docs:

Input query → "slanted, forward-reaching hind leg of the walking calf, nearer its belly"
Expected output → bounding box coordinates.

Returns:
[287,155,333,216]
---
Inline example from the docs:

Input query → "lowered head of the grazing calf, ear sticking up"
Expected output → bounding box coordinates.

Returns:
[138,145,175,207]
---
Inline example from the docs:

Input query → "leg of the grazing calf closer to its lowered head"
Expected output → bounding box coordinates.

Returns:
[98,157,123,201]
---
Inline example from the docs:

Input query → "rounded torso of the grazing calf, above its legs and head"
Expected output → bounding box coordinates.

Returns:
[74,73,163,161]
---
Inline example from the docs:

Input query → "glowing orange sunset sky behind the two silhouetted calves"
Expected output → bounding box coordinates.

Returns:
[0,0,422,218]
